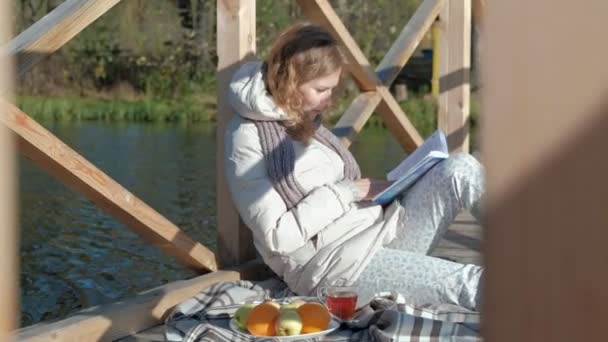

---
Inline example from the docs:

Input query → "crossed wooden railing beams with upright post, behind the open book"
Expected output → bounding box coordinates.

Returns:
[297,0,471,152]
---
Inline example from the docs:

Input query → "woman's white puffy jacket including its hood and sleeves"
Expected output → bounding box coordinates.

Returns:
[225,63,400,295]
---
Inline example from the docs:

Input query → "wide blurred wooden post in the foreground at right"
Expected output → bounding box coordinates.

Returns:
[484,0,608,342]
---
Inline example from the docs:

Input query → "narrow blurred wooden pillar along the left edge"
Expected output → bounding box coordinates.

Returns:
[0,1,20,341]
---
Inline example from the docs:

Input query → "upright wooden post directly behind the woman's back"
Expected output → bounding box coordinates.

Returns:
[216,0,256,266]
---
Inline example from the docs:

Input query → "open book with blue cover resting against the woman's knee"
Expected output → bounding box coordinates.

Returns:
[372,130,449,204]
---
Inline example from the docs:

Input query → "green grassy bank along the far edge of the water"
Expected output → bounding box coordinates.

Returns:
[17,95,479,146]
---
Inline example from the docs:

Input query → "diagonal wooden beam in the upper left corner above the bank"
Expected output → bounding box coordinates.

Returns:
[0,0,120,76]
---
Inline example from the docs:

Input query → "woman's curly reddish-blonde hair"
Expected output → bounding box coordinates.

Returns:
[262,23,345,142]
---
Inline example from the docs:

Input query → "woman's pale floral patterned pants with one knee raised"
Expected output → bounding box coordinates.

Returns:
[354,153,485,310]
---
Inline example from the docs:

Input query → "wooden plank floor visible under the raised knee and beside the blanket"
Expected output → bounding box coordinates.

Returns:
[119,212,481,342]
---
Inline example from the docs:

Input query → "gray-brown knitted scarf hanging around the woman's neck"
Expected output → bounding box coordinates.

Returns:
[254,120,361,209]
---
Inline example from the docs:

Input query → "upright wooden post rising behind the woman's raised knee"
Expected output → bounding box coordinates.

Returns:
[437,0,471,152]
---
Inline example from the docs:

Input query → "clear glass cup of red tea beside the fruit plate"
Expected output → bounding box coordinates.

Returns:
[317,286,357,321]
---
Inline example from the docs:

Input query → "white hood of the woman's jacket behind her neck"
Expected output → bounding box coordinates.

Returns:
[228,62,287,121]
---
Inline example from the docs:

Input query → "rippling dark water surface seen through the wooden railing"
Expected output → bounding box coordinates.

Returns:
[19,123,403,326]
